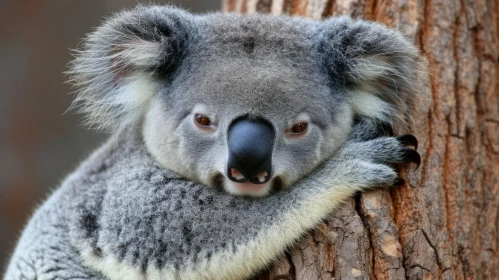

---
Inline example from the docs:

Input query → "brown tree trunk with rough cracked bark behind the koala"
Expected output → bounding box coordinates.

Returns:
[224,0,499,280]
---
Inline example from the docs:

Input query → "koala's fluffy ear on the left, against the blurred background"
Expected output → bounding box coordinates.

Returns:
[68,6,192,130]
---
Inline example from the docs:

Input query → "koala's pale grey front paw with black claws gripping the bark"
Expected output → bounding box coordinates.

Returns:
[341,134,421,188]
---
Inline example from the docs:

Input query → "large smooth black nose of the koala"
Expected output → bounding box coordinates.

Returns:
[227,118,275,184]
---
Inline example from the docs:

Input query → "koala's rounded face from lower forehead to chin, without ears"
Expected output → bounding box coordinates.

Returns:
[144,56,352,196]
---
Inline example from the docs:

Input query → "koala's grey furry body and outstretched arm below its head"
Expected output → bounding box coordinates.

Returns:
[6,126,416,279]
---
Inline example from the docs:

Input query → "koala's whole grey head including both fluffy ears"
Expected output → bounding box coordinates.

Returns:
[70,6,422,196]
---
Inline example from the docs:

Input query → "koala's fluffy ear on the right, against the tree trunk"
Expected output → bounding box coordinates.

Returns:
[317,17,423,131]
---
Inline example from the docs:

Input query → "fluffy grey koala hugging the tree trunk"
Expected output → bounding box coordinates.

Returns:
[5,6,421,280]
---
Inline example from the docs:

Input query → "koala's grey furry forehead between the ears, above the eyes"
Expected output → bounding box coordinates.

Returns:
[160,15,341,120]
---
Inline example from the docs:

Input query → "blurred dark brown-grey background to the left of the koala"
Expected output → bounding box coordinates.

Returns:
[0,0,221,276]
